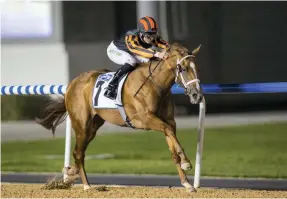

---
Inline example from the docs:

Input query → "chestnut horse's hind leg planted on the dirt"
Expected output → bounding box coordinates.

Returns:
[72,114,105,190]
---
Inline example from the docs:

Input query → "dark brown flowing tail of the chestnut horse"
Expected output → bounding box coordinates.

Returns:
[35,96,67,135]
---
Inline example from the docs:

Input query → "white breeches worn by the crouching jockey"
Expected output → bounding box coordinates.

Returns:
[107,42,149,66]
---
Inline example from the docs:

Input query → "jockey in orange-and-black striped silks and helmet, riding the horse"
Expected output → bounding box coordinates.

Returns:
[104,16,169,99]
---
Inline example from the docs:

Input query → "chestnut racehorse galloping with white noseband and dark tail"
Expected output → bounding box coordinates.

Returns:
[36,43,203,192]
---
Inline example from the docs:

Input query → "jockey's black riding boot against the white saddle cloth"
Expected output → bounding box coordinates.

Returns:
[104,64,134,100]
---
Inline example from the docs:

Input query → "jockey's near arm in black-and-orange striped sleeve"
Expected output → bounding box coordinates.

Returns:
[125,35,156,58]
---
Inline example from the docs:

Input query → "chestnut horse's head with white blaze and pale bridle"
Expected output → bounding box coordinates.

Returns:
[167,44,202,104]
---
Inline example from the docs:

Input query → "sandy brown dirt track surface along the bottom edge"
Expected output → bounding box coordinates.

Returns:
[1,183,287,198]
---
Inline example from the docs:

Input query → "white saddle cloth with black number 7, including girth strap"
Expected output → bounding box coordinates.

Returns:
[93,72,134,128]
